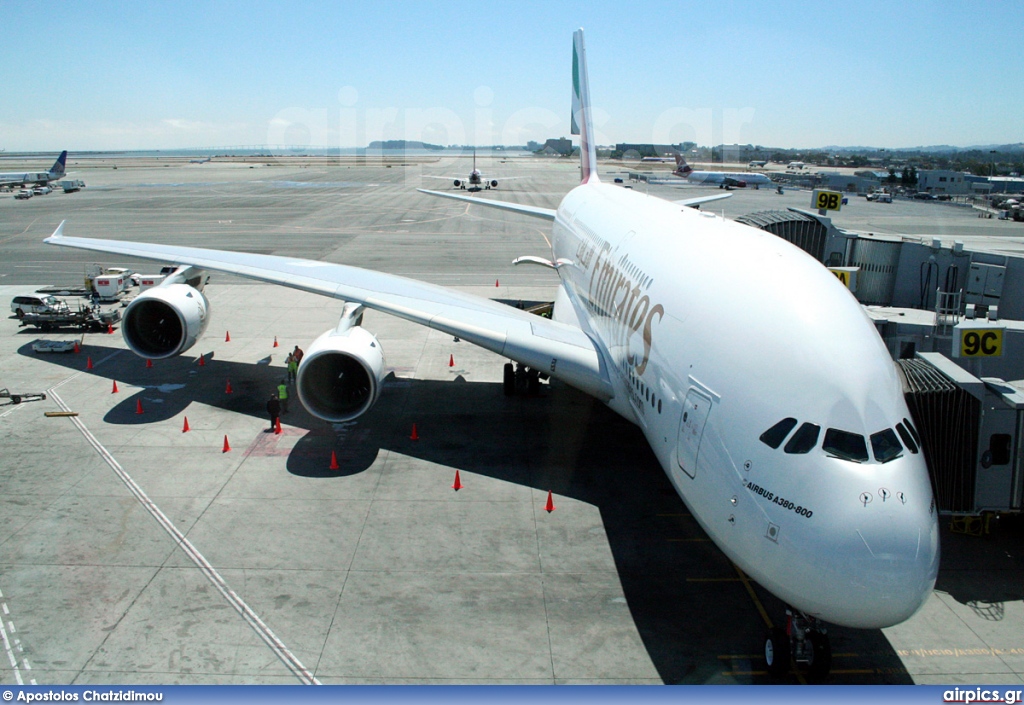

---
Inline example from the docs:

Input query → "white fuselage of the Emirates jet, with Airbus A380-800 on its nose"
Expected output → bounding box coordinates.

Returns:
[553,183,939,628]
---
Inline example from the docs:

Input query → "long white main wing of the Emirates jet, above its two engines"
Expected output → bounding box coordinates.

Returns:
[43,222,612,401]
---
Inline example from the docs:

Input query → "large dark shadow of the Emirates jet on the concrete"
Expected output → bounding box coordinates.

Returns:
[18,342,912,683]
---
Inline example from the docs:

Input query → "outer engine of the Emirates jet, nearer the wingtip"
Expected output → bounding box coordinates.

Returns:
[121,284,210,360]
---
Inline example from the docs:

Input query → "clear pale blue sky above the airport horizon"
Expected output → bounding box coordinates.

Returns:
[0,0,1024,152]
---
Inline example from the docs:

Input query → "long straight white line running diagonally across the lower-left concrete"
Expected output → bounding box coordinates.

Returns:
[47,385,319,686]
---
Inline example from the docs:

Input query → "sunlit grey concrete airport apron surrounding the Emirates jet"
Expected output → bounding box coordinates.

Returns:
[0,158,1024,685]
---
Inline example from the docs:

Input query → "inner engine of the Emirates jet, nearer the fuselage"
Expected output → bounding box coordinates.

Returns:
[296,326,385,423]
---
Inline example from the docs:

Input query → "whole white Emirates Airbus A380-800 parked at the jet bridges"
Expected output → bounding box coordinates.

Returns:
[46,30,939,673]
